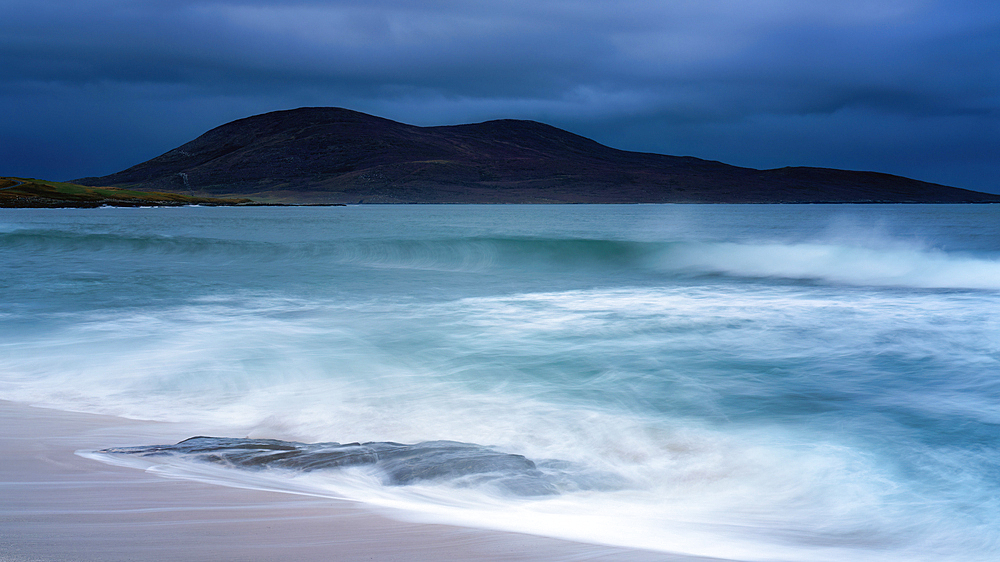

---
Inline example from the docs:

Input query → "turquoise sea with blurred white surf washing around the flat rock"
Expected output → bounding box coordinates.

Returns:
[0,205,1000,562]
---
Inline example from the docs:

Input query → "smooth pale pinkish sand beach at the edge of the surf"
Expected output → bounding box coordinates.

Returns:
[0,401,724,562]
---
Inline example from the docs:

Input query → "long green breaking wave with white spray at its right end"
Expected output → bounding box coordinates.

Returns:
[0,225,1000,290]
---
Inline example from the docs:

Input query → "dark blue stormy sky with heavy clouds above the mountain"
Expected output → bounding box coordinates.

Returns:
[0,0,1000,193]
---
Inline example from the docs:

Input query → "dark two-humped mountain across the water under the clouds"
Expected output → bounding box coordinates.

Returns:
[75,107,1000,203]
